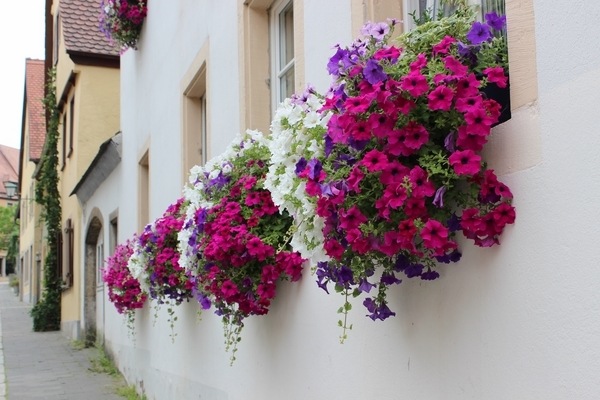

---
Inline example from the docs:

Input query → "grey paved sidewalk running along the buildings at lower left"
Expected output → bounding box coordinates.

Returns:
[0,282,123,400]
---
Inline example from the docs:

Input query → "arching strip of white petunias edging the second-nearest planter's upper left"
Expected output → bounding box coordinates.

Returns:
[177,130,266,272]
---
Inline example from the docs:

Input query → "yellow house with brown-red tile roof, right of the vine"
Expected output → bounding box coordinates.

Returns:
[47,0,120,339]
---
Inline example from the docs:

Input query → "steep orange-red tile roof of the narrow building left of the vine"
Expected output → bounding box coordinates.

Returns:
[25,58,46,161]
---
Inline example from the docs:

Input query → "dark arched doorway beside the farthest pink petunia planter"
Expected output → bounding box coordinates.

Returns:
[83,209,104,346]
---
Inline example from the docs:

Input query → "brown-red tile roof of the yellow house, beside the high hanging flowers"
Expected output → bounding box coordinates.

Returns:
[59,0,119,55]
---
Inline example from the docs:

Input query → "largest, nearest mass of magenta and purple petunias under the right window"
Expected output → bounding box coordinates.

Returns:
[304,9,515,340]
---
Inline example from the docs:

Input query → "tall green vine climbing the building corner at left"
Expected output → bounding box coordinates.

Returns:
[31,70,62,332]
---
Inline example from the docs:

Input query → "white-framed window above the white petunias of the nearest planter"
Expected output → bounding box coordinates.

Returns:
[270,0,295,112]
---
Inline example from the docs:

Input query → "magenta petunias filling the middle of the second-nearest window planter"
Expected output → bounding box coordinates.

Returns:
[197,175,304,316]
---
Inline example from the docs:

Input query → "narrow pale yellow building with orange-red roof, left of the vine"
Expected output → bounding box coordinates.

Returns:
[18,59,46,304]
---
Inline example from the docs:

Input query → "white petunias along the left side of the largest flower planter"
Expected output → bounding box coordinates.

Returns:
[264,91,331,265]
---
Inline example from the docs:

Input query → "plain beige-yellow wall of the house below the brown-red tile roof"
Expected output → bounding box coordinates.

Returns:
[56,15,120,337]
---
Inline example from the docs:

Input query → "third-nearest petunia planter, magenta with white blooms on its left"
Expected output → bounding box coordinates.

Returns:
[129,198,194,338]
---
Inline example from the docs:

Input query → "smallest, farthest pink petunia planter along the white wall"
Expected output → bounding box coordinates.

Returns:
[102,239,147,330]
